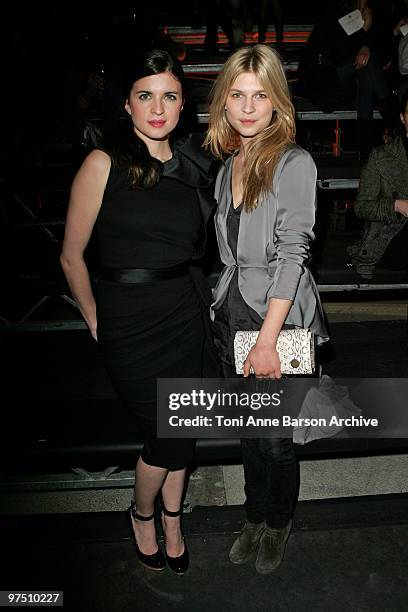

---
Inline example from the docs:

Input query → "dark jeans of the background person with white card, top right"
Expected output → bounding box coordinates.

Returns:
[337,53,391,119]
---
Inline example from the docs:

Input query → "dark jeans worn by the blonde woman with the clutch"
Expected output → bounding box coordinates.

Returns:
[223,363,298,528]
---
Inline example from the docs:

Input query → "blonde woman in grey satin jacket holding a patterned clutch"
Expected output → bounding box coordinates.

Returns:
[206,45,327,574]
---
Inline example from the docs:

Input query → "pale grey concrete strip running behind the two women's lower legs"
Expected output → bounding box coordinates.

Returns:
[0,454,408,514]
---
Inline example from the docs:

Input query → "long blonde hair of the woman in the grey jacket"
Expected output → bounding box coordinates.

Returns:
[204,45,296,212]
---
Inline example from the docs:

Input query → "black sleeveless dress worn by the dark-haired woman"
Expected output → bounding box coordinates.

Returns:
[96,146,214,469]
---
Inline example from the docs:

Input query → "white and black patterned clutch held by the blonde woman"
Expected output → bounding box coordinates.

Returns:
[234,327,315,374]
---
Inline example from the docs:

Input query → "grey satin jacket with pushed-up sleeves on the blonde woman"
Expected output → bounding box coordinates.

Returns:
[212,145,328,344]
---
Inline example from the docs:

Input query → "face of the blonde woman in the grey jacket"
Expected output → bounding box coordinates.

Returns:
[225,72,274,139]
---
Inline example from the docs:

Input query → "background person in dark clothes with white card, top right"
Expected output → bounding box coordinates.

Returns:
[298,0,399,158]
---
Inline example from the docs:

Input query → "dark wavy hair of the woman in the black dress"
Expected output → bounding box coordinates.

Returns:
[102,49,184,189]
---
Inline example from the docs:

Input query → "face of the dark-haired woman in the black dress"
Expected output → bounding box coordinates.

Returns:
[125,72,183,143]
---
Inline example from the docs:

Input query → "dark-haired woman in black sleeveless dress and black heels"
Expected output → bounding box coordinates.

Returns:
[61,50,217,574]
